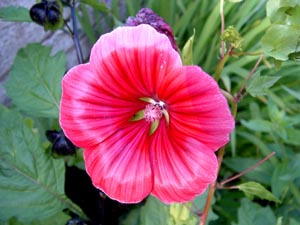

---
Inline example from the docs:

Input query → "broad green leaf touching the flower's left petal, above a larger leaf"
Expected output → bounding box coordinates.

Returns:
[5,44,66,118]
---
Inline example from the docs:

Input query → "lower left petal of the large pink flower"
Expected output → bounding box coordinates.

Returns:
[84,121,153,203]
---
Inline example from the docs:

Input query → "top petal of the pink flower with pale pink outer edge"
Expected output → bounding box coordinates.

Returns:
[90,24,182,98]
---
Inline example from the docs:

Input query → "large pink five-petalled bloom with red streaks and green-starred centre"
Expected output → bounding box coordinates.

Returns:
[60,25,234,203]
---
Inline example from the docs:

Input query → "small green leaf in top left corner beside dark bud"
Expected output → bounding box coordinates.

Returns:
[0,6,32,22]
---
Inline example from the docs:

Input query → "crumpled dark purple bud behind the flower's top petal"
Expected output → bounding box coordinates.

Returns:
[125,8,178,51]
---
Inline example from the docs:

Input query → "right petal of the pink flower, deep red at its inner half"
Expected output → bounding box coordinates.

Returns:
[158,66,234,150]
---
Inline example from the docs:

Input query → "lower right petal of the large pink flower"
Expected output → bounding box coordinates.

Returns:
[150,120,218,203]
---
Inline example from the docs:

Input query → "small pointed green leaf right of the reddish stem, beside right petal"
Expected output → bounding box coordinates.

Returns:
[246,72,281,97]
